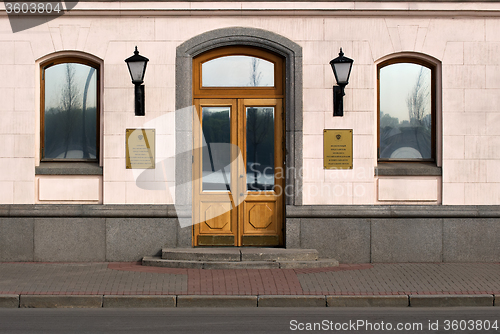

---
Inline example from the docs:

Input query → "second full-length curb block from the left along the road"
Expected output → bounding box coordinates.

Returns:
[102,295,177,308]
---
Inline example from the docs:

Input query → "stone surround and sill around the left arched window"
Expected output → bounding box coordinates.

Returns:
[35,51,104,175]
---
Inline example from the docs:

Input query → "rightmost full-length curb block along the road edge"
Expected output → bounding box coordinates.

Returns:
[409,295,495,307]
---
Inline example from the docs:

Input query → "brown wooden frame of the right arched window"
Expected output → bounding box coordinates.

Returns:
[377,56,437,164]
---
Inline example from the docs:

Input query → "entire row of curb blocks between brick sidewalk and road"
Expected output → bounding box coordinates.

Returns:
[0,294,500,308]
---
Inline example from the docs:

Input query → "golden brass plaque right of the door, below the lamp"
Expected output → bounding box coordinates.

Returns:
[323,129,352,169]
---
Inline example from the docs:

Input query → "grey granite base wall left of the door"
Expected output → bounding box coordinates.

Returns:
[0,205,181,262]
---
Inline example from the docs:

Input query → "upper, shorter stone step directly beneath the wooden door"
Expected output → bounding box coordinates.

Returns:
[162,247,318,262]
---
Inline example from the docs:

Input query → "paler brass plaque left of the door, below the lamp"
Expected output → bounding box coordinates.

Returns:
[125,129,155,169]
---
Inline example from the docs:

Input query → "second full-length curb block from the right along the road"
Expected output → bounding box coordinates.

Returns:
[326,295,409,307]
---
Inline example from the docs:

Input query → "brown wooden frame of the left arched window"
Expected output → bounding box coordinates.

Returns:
[39,56,101,163]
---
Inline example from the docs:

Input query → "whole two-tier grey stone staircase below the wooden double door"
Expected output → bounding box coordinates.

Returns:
[142,247,339,269]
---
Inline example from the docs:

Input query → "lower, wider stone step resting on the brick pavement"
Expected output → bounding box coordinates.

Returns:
[142,257,339,269]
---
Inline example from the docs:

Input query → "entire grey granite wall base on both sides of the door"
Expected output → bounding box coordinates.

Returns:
[0,205,500,263]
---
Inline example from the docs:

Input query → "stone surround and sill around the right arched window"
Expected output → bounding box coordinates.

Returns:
[374,52,443,176]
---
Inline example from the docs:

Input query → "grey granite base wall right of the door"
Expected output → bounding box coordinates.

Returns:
[286,205,500,263]
